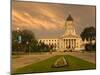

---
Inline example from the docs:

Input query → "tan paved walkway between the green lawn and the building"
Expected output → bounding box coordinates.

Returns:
[12,52,96,71]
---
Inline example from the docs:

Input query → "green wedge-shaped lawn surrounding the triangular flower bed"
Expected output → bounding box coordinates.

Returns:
[14,55,96,74]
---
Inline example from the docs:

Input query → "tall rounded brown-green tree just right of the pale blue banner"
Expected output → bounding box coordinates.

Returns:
[21,30,36,52]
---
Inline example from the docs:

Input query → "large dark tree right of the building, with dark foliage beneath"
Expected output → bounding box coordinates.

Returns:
[80,27,96,51]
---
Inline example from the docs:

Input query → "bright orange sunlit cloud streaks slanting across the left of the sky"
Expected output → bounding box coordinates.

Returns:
[12,9,63,30]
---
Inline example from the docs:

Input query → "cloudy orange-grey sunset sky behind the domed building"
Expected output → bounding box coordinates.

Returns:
[12,0,96,38]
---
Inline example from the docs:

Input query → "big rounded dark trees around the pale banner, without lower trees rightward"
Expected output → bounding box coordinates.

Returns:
[12,30,37,52]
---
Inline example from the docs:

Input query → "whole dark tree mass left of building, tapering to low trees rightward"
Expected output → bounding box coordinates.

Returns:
[12,30,53,53]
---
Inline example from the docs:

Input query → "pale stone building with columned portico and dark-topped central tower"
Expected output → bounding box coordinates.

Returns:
[38,15,83,51]
